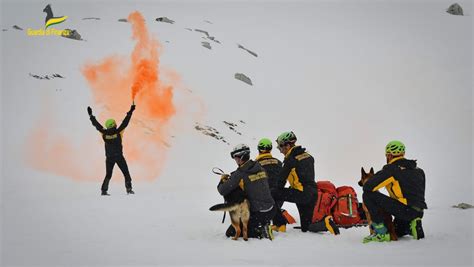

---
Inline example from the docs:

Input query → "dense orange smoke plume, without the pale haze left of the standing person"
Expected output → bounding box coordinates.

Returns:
[82,11,176,180]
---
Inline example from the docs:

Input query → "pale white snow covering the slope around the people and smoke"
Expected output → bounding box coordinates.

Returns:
[0,1,473,266]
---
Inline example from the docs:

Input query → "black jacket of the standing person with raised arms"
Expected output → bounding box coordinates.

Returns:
[90,110,133,157]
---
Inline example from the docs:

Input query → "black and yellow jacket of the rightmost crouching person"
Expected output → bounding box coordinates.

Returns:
[364,157,428,209]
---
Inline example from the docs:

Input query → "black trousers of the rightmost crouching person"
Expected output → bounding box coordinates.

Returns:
[362,191,423,237]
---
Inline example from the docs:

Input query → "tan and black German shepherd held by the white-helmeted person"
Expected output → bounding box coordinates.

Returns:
[209,175,250,241]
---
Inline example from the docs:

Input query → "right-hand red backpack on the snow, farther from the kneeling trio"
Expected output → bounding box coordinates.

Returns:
[332,186,360,226]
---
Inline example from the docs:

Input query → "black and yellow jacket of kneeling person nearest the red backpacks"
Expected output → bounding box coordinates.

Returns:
[278,146,317,194]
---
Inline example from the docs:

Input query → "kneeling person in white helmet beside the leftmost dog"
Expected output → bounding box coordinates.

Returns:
[217,144,275,240]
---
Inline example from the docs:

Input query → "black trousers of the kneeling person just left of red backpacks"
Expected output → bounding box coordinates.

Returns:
[272,188,318,232]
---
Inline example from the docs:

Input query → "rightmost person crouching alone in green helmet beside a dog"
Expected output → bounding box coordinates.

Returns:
[362,141,427,243]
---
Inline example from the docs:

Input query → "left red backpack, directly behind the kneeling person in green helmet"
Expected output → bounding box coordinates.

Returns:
[311,181,337,223]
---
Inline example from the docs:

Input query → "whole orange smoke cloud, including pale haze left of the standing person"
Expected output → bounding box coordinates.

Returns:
[27,9,198,183]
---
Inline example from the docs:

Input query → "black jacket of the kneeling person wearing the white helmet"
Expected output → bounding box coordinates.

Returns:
[217,160,275,211]
